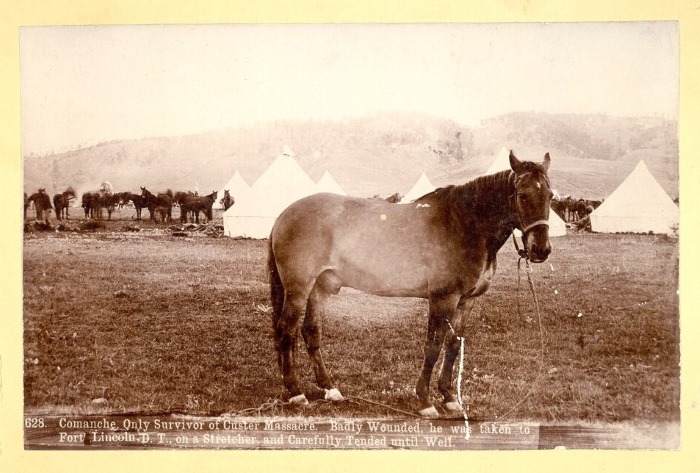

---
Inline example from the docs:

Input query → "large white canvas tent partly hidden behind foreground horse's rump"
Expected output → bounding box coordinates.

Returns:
[224,147,316,238]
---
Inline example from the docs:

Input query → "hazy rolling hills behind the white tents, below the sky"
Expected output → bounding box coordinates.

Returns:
[24,112,678,202]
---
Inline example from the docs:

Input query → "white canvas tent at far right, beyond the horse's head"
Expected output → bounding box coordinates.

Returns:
[591,161,679,234]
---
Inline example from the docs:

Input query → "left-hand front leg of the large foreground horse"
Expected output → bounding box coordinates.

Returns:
[416,295,459,417]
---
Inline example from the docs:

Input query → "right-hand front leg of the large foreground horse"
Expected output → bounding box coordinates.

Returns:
[438,297,476,412]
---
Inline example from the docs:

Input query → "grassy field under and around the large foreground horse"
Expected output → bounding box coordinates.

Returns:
[23,215,680,423]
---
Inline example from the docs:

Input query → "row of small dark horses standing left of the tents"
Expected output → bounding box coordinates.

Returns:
[24,187,235,224]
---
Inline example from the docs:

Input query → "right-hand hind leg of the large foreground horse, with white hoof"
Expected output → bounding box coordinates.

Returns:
[301,284,343,401]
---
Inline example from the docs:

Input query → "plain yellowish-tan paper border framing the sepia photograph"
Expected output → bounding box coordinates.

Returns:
[0,0,700,473]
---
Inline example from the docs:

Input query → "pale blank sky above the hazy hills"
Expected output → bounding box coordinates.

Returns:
[20,22,679,156]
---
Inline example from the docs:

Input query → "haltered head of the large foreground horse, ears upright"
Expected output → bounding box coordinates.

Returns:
[509,151,553,263]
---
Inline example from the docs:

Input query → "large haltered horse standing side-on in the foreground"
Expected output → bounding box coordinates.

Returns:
[268,151,552,417]
